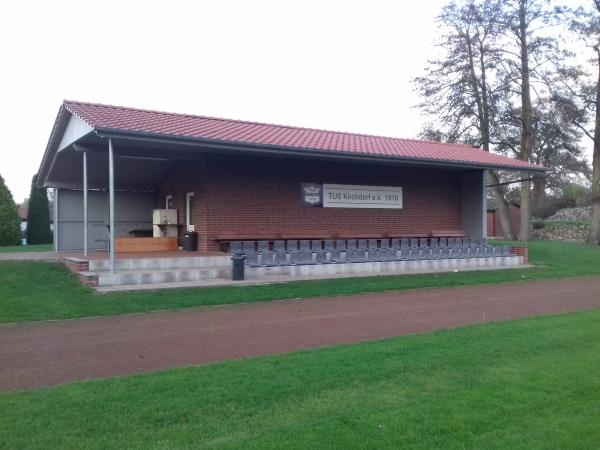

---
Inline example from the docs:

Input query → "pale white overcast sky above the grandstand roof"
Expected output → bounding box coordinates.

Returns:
[0,0,592,202]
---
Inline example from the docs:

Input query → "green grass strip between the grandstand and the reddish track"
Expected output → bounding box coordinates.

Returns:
[0,241,600,323]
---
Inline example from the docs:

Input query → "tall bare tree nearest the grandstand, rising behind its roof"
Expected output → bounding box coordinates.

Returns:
[414,0,515,240]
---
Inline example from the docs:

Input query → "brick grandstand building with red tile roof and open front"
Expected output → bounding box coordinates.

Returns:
[38,101,544,258]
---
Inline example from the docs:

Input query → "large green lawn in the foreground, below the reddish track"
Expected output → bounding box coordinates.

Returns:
[0,310,600,450]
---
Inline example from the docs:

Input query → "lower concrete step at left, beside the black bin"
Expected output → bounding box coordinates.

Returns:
[96,264,232,286]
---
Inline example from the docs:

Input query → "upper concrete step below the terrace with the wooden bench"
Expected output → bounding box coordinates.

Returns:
[89,255,231,272]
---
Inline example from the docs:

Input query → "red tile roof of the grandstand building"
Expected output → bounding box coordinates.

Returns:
[64,101,543,171]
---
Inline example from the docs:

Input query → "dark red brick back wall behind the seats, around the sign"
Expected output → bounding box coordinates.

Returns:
[157,155,461,250]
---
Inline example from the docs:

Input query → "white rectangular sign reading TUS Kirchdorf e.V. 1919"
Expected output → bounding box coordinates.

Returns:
[323,184,402,209]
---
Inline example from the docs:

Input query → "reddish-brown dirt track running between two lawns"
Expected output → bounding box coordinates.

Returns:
[0,278,600,391]
